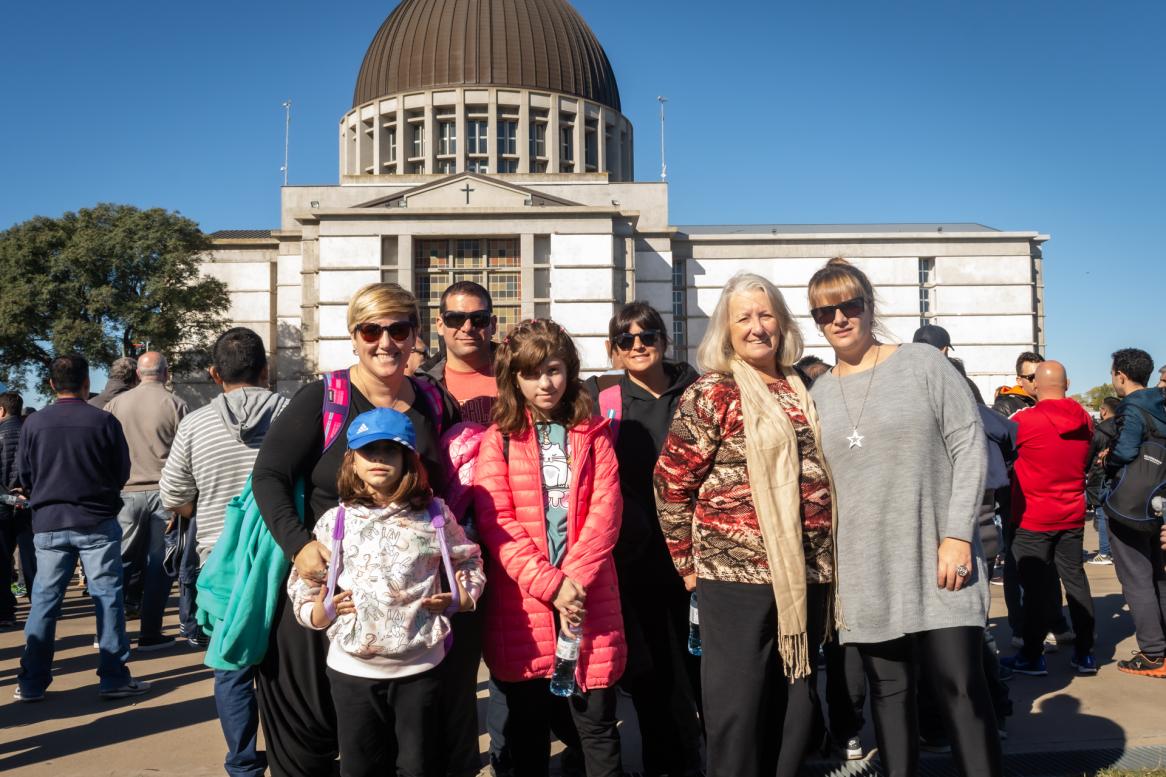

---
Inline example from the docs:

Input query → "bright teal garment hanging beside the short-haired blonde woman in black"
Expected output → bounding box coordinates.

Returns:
[196,477,304,670]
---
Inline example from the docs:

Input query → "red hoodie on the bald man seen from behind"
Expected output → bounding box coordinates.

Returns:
[1012,399,1093,532]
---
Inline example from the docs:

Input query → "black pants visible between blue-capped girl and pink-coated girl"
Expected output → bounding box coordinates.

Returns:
[437,613,482,777]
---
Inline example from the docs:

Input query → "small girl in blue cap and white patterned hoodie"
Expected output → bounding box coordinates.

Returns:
[288,407,485,777]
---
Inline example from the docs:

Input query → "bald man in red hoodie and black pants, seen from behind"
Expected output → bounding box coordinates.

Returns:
[1000,362,1097,676]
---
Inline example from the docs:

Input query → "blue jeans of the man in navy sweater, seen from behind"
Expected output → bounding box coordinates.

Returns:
[19,517,131,695]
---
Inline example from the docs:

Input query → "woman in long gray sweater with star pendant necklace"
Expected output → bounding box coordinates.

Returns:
[809,259,1002,777]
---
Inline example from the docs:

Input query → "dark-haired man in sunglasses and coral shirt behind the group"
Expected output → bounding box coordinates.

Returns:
[419,281,498,426]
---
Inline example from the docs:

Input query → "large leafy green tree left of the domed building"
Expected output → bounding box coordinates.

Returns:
[0,203,230,386]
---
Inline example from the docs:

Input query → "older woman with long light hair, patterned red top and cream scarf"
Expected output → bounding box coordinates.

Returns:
[654,273,834,777]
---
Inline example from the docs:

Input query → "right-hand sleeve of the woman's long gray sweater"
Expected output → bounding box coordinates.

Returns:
[923,352,988,543]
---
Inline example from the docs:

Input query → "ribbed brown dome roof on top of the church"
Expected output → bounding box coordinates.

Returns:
[352,0,620,111]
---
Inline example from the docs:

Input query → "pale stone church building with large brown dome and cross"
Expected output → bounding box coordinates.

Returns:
[205,0,1048,397]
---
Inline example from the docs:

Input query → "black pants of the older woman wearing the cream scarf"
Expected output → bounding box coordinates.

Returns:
[696,579,826,777]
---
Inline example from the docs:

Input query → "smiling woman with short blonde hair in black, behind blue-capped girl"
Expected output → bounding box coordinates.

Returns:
[252,284,466,777]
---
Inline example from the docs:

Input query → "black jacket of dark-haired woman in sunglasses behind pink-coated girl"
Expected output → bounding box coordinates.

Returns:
[584,362,700,583]
